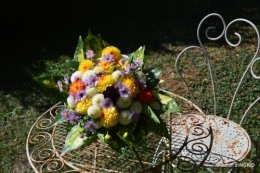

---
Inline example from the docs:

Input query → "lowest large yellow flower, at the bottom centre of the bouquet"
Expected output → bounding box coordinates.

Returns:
[100,107,119,128]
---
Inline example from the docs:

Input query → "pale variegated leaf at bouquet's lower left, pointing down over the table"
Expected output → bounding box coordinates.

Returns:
[61,125,86,156]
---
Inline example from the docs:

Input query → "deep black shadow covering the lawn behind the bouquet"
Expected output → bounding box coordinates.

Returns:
[0,0,260,109]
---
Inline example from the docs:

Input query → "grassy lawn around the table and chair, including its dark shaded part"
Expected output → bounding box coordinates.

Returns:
[0,0,260,172]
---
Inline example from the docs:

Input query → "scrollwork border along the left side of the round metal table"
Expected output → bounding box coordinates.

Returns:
[26,103,72,172]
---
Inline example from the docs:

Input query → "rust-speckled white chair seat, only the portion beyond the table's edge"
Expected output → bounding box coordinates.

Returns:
[204,115,251,167]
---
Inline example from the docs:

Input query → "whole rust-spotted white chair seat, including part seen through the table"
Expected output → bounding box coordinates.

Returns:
[175,115,251,167]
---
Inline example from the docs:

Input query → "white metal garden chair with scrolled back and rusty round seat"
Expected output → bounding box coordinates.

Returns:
[175,13,260,166]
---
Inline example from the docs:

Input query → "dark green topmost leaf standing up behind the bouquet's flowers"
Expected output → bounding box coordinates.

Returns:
[84,30,109,59]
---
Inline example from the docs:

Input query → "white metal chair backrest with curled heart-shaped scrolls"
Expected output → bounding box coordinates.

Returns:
[175,13,260,125]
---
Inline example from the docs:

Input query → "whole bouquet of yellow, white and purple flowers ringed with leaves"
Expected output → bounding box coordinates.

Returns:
[53,32,179,155]
